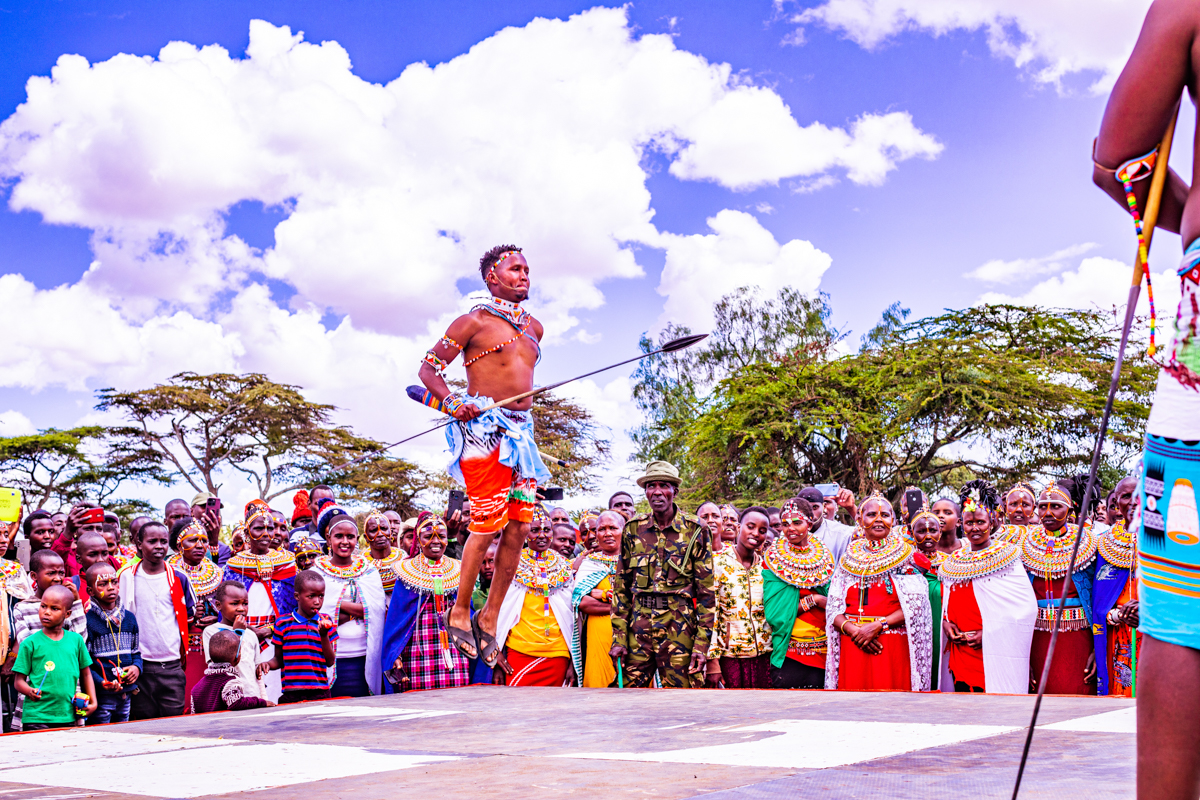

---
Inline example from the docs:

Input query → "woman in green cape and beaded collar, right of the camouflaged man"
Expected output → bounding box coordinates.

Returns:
[762,498,834,688]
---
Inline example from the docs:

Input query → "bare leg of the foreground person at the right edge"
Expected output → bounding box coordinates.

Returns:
[1138,636,1200,800]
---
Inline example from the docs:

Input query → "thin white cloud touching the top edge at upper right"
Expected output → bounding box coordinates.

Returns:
[776,0,1150,92]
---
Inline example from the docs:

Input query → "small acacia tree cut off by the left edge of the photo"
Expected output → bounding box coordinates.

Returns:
[0,426,167,509]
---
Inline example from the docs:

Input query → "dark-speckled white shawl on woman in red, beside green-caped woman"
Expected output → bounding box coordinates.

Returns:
[826,565,934,692]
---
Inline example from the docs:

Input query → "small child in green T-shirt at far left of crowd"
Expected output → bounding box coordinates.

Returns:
[12,584,96,730]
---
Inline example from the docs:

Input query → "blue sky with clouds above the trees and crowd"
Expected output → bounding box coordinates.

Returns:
[0,0,1192,510]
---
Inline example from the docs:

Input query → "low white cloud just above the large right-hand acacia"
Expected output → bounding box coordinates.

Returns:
[979,257,1180,321]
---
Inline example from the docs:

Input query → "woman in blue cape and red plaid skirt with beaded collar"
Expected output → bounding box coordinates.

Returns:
[383,511,470,693]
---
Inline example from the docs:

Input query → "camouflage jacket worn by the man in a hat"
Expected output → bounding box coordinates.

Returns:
[612,506,716,654]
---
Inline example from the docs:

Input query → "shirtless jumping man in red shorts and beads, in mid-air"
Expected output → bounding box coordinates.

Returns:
[419,245,550,669]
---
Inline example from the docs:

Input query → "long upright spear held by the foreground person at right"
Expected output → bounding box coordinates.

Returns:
[1013,106,1180,800]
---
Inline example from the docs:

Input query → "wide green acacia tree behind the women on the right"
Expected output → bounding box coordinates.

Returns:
[684,306,1154,499]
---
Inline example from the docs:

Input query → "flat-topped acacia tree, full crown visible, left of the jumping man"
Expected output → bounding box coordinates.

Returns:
[96,372,403,500]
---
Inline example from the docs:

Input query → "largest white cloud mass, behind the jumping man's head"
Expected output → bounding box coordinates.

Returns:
[0,8,941,489]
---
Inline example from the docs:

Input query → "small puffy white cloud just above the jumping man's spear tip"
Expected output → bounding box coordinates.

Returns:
[659,209,833,330]
